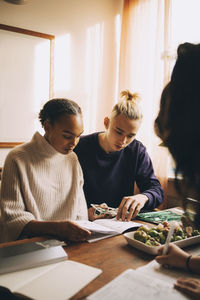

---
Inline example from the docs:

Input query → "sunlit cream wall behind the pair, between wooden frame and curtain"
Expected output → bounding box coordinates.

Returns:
[0,0,123,166]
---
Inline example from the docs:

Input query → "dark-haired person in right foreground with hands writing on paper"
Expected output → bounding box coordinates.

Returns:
[155,43,200,299]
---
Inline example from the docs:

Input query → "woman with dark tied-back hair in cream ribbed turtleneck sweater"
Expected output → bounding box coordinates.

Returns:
[0,99,90,242]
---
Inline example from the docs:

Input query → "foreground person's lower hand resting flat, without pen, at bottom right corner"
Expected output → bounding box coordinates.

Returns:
[174,278,200,300]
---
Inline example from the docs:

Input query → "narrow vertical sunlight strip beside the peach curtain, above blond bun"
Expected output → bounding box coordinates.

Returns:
[114,14,121,104]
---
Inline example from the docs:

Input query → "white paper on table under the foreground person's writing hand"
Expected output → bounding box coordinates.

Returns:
[87,269,188,300]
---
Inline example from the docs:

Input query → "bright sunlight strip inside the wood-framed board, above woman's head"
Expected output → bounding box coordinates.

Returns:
[33,40,50,134]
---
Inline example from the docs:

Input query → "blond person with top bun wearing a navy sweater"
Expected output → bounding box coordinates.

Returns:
[74,91,163,221]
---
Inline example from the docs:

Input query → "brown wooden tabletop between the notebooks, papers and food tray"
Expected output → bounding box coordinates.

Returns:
[0,229,154,300]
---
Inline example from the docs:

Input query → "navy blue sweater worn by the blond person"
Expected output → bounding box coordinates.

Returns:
[74,133,163,210]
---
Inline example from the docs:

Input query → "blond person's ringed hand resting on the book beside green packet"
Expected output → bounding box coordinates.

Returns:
[116,194,148,221]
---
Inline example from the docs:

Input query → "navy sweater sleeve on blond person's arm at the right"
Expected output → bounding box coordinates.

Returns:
[136,147,164,210]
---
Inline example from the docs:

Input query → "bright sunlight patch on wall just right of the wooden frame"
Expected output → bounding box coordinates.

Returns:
[54,33,71,95]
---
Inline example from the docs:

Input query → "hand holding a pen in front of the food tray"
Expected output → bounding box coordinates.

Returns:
[155,244,189,269]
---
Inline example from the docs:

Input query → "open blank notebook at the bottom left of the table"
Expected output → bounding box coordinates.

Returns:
[0,260,102,300]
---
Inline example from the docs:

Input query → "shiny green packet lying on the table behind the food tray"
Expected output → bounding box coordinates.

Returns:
[137,210,181,224]
